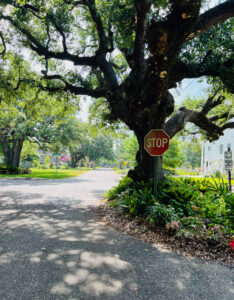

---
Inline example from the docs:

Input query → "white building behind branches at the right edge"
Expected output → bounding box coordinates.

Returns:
[201,129,234,175]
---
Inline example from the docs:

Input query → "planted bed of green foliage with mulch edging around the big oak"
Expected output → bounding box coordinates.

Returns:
[102,177,234,261]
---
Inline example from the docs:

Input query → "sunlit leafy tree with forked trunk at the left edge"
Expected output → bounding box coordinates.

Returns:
[0,54,78,166]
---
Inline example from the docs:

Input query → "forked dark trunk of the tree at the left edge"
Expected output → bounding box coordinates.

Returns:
[1,139,24,167]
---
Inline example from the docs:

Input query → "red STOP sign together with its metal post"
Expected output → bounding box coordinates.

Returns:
[144,129,170,198]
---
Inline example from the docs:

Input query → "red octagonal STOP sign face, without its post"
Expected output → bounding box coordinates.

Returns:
[144,129,170,156]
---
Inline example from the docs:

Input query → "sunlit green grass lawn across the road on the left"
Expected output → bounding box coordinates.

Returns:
[0,168,92,179]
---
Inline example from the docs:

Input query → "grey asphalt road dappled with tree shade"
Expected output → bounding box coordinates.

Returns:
[0,169,234,300]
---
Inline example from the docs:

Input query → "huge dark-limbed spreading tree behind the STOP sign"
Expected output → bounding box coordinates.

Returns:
[0,0,234,180]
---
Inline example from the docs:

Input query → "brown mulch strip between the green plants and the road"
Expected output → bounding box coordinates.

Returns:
[98,202,234,268]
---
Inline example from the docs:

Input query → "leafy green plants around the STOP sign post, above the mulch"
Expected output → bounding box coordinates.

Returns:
[107,177,234,240]
